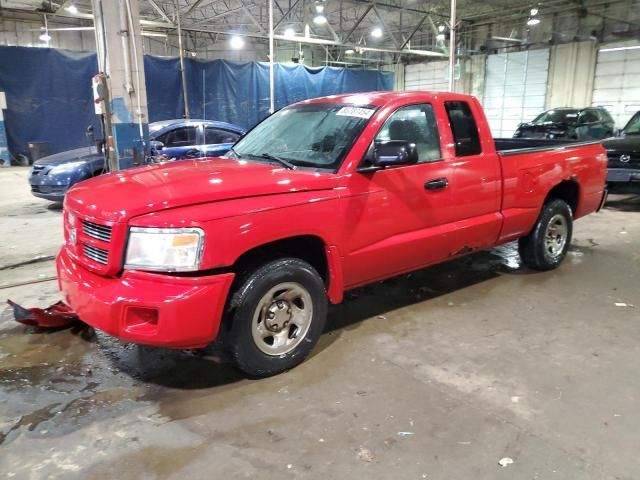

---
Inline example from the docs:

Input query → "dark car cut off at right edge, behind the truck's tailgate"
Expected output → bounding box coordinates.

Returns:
[602,112,640,187]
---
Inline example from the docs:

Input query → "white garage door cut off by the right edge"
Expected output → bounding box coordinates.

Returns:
[592,42,640,128]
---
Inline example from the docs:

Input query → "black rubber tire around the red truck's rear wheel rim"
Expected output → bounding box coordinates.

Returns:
[518,200,573,271]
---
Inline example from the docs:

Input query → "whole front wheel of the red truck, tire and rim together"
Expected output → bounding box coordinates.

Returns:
[223,258,327,377]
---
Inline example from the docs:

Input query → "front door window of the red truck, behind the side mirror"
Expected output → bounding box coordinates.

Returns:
[375,103,442,162]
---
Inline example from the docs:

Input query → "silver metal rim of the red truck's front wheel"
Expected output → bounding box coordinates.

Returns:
[251,282,313,356]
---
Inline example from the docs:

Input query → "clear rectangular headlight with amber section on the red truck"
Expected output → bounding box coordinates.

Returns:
[125,227,204,272]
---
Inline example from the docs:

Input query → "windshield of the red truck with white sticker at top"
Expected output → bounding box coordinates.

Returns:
[227,103,375,170]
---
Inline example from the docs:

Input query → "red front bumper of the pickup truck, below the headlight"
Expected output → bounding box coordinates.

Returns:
[56,248,234,348]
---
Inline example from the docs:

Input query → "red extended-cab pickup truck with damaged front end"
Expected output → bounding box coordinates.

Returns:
[57,92,607,376]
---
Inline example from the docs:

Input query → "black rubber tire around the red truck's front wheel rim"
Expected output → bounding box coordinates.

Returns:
[222,258,327,378]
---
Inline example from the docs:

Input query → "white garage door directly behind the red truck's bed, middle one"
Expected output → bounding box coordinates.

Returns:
[483,49,549,137]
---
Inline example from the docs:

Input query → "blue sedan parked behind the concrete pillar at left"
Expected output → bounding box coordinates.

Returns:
[29,120,245,202]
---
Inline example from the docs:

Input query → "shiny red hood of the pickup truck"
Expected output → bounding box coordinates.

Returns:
[65,158,338,222]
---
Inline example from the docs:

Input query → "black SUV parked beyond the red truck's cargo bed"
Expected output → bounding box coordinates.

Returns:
[513,107,615,140]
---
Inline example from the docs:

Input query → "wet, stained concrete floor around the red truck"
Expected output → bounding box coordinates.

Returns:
[0,169,640,480]
